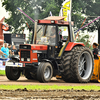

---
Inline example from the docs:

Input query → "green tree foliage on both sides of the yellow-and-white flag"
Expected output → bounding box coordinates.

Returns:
[1,0,100,45]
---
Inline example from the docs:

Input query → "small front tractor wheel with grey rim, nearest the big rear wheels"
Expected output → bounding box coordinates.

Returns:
[37,62,53,83]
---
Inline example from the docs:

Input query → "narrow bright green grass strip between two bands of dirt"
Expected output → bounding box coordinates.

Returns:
[0,85,100,90]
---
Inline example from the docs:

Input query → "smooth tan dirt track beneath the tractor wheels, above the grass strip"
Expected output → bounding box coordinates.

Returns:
[0,76,100,86]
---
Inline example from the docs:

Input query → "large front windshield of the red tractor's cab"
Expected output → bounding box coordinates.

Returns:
[36,25,56,45]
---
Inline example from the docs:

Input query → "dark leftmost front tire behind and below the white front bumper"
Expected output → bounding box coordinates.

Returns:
[5,60,21,80]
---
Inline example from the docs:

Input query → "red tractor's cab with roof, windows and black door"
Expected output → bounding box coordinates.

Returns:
[33,16,74,58]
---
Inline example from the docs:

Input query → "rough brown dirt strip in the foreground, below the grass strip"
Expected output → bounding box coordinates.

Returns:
[0,89,100,100]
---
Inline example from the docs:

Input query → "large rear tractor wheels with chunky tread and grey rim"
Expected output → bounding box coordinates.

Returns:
[61,46,94,83]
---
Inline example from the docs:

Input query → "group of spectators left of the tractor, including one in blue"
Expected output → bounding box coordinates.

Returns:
[0,43,19,58]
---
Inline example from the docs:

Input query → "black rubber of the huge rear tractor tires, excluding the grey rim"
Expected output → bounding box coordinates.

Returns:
[61,46,93,83]
